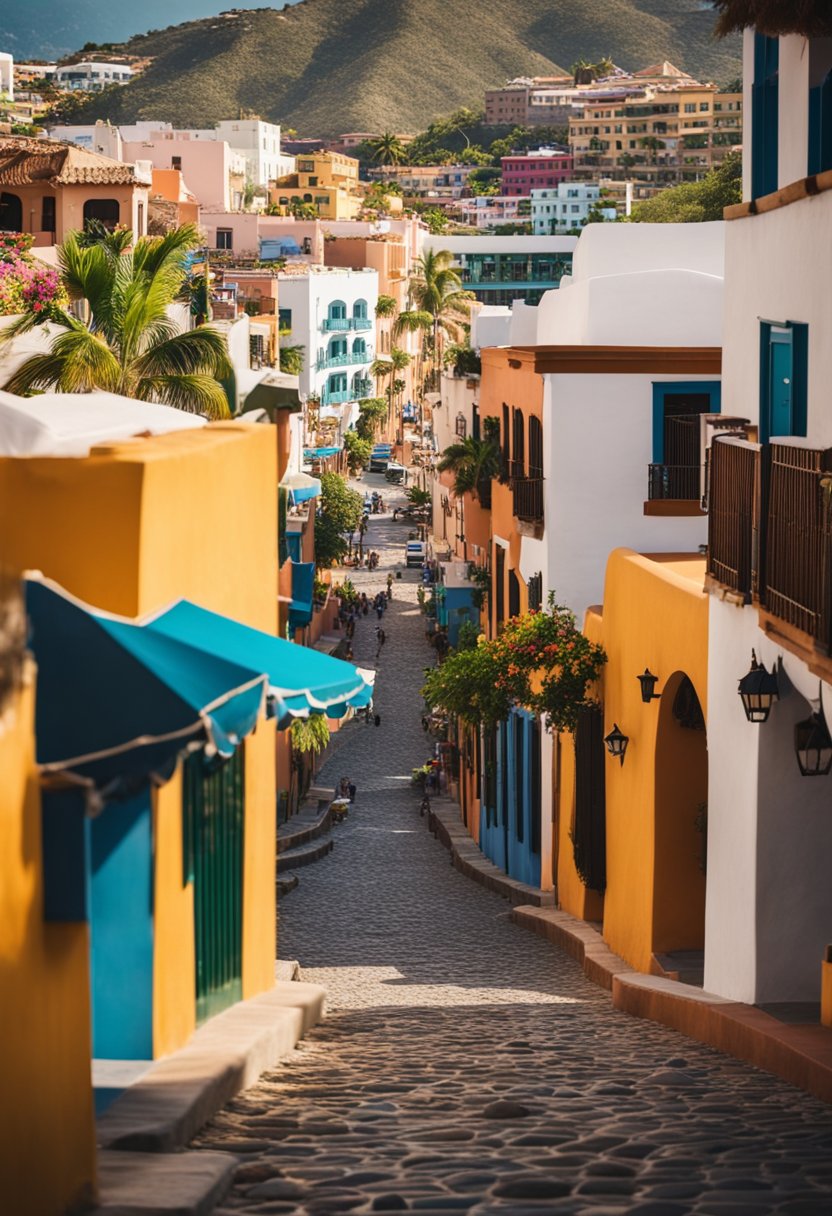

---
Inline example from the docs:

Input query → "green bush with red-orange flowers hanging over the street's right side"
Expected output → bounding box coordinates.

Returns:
[422,595,607,731]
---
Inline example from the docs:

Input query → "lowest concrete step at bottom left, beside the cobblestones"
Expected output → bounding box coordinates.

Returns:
[90,1149,233,1216]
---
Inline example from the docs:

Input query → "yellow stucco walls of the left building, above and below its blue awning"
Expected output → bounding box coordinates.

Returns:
[0,423,277,1070]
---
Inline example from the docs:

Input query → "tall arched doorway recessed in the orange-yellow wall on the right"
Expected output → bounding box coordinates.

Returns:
[653,671,708,984]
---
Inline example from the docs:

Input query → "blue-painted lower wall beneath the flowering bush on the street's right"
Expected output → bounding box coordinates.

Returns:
[479,709,540,886]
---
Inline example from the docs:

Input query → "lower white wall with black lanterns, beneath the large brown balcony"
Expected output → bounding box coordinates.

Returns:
[704,597,832,1003]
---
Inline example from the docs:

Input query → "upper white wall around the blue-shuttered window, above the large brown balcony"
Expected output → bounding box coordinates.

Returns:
[723,192,832,446]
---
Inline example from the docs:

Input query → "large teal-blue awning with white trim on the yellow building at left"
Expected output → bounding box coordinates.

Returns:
[26,576,373,788]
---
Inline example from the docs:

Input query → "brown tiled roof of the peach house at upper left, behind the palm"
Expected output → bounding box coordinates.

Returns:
[0,135,136,186]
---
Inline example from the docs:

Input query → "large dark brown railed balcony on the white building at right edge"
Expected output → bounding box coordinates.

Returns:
[708,439,832,655]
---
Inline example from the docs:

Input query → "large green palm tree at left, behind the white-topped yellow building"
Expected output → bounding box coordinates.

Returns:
[2,225,231,418]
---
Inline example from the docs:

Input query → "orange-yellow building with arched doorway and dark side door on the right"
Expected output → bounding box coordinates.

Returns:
[556,550,708,974]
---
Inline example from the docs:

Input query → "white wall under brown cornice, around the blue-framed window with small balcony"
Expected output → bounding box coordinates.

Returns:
[544,375,708,620]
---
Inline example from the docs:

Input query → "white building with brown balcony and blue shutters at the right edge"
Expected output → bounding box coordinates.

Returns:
[704,26,832,1020]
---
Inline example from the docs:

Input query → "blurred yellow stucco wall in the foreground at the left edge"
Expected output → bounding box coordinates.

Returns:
[0,676,95,1216]
